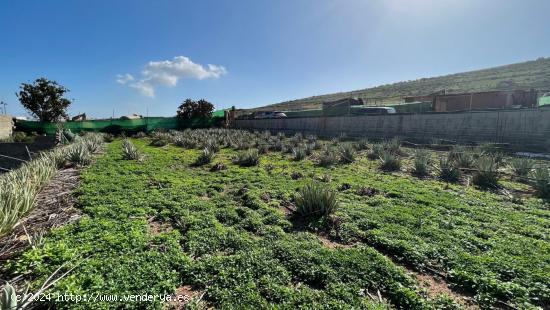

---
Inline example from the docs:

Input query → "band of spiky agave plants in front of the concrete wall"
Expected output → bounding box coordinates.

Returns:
[125,129,550,198]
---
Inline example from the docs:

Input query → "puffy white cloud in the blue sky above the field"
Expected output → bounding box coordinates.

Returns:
[117,56,227,97]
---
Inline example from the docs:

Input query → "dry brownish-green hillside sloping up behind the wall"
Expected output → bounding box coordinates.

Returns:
[254,57,550,111]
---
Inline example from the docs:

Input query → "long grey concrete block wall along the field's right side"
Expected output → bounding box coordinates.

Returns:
[235,108,550,151]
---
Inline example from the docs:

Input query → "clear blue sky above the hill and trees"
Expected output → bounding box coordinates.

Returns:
[0,0,550,117]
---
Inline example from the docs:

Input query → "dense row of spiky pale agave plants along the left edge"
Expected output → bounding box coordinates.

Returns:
[0,132,103,235]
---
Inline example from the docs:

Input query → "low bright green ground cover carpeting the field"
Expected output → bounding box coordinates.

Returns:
[5,130,550,309]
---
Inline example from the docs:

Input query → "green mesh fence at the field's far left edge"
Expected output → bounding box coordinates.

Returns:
[15,117,223,135]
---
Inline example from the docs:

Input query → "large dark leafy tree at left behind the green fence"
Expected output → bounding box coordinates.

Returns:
[16,78,71,122]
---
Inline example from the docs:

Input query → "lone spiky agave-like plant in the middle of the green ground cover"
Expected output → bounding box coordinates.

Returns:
[294,182,338,217]
